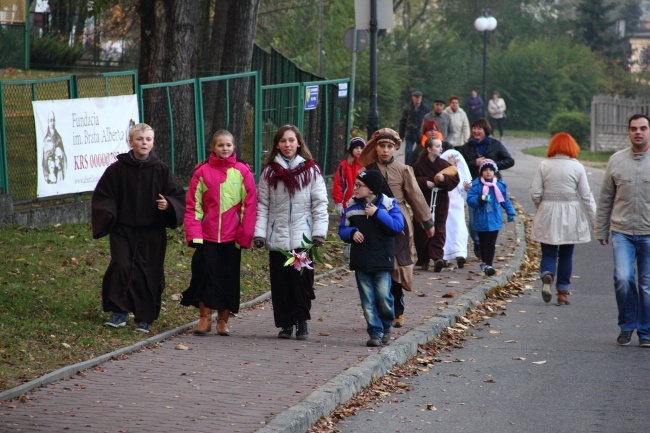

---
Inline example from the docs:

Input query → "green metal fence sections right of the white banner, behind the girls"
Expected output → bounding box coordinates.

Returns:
[139,71,350,183]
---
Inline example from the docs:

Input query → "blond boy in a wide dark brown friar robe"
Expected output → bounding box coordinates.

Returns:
[92,123,185,333]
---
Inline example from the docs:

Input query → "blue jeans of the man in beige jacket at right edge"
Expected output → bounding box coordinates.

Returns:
[612,232,650,339]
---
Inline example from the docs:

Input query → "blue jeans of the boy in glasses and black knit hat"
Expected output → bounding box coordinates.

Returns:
[354,271,395,338]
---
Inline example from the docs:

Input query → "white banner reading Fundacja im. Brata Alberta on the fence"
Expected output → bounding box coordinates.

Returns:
[32,95,140,197]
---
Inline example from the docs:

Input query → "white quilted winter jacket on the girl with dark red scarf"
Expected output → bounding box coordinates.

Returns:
[255,154,329,251]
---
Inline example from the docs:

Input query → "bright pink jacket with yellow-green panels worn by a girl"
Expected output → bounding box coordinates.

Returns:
[185,153,257,248]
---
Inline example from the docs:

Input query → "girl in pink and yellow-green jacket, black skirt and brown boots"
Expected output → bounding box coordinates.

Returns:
[181,130,257,336]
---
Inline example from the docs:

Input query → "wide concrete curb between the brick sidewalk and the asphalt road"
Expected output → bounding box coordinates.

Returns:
[257,217,526,433]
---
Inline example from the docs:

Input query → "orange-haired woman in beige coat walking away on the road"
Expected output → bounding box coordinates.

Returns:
[530,132,596,305]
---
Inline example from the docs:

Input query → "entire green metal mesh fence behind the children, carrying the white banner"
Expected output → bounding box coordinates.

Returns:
[0,71,350,204]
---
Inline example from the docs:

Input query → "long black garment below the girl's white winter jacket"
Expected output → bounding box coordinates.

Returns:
[269,251,316,328]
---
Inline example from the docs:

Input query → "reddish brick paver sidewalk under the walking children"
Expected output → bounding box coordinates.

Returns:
[0,221,524,433]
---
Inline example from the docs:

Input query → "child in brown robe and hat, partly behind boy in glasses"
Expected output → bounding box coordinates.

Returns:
[359,128,433,328]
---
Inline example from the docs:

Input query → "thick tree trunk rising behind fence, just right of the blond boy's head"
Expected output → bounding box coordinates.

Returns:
[136,0,201,179]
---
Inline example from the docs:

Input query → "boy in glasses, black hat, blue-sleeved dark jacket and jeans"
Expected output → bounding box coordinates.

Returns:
[339,170,404,347]
